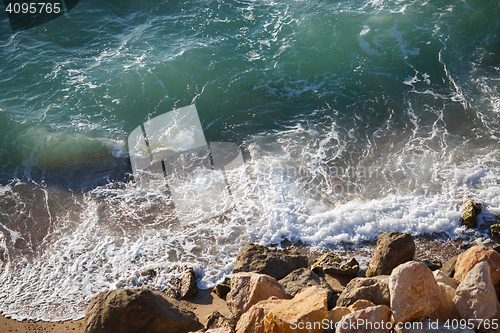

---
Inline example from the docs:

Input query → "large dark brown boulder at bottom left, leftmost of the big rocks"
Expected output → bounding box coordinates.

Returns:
[83,289,201,333]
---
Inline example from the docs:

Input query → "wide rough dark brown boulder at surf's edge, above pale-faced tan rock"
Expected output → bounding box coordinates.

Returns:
[233,243,308,280]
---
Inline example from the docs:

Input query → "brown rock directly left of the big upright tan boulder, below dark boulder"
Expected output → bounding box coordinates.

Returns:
[337,275,391,306]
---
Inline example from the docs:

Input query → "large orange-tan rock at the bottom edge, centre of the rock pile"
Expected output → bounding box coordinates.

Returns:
[264,286,328,333]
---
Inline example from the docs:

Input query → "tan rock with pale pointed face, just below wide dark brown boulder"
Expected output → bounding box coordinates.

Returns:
[226,272,291,319]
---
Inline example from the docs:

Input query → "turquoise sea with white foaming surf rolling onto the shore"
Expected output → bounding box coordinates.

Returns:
[0,0,500,320]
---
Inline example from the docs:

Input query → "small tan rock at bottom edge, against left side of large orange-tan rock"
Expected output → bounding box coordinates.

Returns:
[236,296,285,333]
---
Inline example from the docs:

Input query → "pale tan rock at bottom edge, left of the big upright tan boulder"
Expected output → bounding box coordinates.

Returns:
[337,305,392,333]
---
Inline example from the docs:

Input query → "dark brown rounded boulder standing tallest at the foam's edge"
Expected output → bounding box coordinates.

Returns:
[366,231,415,277]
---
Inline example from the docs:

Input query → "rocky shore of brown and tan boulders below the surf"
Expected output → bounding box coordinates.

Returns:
[3,197,500,333]
